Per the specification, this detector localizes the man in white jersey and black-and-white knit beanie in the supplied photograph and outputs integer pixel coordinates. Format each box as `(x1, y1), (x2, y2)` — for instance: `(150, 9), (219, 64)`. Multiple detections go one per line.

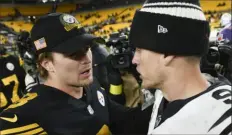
(129, 0), (232, 134)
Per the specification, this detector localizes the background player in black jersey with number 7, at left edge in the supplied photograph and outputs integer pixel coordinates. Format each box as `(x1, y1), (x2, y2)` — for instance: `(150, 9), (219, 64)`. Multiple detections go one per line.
(0, 46), (26, 112)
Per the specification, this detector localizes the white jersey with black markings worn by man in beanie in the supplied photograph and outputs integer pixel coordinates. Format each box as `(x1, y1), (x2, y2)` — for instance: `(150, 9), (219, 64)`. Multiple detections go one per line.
(148, 84), (232, 135)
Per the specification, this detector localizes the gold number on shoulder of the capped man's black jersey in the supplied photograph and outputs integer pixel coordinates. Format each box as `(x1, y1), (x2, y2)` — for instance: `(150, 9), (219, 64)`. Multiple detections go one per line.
(7, 93), (38, 109)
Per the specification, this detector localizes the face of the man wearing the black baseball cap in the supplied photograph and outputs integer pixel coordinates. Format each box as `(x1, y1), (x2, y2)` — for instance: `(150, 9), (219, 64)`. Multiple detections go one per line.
(53, 48), (93, 87)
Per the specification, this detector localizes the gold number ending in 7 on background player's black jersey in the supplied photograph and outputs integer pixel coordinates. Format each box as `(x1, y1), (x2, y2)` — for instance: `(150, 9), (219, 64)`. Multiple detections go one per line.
(0, 74), (19, 107)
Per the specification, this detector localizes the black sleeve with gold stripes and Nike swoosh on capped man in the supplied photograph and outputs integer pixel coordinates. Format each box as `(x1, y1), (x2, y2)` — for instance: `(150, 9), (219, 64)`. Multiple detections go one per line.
(0, 93), (46, 135)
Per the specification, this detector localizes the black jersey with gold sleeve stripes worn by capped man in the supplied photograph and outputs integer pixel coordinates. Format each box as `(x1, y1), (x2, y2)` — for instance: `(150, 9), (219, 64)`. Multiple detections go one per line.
(0, 79), (145, 135)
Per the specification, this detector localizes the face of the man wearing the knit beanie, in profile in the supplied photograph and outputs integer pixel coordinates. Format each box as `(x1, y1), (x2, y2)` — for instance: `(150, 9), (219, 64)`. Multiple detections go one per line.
(132, 48), (163, 88)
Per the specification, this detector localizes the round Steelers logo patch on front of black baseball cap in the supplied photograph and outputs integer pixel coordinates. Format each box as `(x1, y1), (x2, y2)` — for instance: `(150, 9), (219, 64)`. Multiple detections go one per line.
(60, 14), (81, 31)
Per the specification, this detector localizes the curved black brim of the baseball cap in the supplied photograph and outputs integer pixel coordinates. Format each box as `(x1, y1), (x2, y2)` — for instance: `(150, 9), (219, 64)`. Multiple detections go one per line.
(52, 34), (105, 54)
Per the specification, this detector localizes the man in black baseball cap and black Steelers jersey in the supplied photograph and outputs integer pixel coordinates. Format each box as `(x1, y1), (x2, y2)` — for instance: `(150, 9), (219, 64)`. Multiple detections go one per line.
(0, 13), (147, 135)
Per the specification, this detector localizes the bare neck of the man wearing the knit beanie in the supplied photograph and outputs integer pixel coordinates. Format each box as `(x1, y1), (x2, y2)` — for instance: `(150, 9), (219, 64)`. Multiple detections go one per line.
(161, 68), (209, 102)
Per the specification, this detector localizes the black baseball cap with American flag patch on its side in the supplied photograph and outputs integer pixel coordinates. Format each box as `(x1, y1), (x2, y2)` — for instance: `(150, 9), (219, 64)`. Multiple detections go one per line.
(31, 13), (104, 55)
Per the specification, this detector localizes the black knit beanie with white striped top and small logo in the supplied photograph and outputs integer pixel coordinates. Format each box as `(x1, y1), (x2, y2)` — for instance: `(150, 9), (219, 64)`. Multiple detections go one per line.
(129, 0), (209, 56)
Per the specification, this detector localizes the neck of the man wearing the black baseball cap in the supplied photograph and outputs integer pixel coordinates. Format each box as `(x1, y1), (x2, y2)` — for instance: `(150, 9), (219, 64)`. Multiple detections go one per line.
(44, 79), (83, 99)
